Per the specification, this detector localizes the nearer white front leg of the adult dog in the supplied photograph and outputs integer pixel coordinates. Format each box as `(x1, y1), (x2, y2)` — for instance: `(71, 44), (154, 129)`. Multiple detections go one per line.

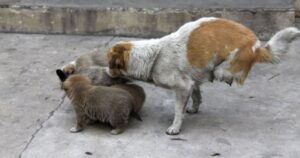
(166, 86), (192, 135)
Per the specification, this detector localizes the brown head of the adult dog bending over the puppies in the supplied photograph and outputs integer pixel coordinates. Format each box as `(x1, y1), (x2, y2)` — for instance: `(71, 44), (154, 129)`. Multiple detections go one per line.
(107, 42), (132, 77)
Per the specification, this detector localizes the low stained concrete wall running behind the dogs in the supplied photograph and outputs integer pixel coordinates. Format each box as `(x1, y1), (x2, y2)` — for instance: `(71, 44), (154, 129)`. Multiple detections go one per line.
(0, 0), (295, 39)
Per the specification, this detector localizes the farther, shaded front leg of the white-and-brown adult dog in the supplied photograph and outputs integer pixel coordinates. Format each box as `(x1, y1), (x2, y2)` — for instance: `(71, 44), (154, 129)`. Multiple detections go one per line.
(186, 85), (202, 114)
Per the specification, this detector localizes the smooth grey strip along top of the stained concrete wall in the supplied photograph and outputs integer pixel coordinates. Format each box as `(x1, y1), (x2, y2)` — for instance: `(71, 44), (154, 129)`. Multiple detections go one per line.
(15, 0), (293, 9)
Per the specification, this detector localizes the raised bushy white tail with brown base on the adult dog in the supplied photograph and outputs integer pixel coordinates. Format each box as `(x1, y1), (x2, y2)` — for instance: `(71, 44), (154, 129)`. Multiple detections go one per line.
(255, 27), (300, 63)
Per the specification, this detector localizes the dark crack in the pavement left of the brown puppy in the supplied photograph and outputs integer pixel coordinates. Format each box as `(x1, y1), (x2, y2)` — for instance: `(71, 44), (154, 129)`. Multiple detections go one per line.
(19, 94), (66, 158)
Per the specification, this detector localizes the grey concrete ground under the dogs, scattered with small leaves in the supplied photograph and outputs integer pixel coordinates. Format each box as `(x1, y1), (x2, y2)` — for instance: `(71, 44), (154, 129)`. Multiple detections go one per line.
(0, 34), (300, 158)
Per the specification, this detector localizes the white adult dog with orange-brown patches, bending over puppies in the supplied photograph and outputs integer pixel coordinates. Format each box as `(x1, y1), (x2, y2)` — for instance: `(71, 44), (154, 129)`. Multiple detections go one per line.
(107, 17), (300, 135)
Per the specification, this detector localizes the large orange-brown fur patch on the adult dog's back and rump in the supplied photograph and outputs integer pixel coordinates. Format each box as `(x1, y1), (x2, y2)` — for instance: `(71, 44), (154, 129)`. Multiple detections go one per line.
(187, 19), (257, 83)
